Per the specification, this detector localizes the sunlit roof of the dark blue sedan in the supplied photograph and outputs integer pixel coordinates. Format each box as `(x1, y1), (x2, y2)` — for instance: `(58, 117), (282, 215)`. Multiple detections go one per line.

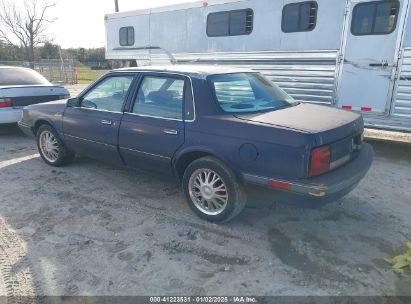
(111, 64), (255, 79)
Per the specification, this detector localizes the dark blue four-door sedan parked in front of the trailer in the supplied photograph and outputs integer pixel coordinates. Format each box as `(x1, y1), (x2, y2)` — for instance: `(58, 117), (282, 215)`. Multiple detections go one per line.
(19, 65), (373, 222)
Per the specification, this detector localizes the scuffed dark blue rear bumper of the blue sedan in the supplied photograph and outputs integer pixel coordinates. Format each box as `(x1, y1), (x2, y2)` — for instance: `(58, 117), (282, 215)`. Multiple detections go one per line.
(243, 143), (374, 206)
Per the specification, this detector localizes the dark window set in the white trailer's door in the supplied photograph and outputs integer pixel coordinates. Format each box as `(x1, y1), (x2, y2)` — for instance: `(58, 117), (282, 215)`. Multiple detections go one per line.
(351, 0), (400, 36)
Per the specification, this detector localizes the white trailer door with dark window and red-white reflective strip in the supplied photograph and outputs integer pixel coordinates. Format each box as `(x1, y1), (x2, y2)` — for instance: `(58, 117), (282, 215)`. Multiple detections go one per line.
(337, 0), (408, 114)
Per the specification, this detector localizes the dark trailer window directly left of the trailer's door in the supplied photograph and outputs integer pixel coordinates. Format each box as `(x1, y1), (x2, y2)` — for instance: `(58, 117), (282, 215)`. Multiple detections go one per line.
(281, 1), (318, 33)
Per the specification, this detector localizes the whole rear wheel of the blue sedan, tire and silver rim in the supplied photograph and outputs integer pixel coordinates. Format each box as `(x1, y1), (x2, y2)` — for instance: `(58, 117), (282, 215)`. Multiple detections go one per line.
(182, 156), (247, 223)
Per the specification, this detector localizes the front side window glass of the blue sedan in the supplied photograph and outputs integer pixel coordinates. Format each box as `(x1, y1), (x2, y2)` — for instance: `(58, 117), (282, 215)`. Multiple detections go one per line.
(81, 76), (134, 112)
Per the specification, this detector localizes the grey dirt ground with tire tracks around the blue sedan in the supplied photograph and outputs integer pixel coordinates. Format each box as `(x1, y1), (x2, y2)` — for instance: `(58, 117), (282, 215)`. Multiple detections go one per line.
(0, 85), (411, 295)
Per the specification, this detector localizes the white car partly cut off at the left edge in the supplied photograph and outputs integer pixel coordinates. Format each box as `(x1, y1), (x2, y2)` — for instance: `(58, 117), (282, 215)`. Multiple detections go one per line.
(0, 66), (70, 124)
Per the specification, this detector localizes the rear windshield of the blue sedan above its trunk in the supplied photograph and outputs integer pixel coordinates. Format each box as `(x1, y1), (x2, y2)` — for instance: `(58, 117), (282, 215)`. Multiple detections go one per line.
(208, 73), (298, 113)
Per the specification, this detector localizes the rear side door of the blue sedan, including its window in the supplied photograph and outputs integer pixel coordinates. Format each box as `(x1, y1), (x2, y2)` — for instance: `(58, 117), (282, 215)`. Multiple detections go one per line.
(119, 73), (191, 173)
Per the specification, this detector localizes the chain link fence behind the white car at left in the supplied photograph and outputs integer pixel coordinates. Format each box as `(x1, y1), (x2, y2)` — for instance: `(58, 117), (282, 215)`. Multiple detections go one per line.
(0, 59), (77, 84)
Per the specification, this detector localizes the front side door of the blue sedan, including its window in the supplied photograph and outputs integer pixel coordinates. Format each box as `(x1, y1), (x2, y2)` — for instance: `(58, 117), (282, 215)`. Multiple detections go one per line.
(63, 73), (134, 163)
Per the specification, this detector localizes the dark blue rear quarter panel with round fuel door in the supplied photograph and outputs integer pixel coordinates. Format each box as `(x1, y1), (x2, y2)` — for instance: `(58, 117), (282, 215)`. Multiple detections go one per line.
(177, 116), (315, 178)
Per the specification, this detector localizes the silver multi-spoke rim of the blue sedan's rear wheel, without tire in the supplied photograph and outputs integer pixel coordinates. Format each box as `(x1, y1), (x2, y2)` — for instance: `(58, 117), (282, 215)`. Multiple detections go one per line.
(188, 169), (228, 215)
